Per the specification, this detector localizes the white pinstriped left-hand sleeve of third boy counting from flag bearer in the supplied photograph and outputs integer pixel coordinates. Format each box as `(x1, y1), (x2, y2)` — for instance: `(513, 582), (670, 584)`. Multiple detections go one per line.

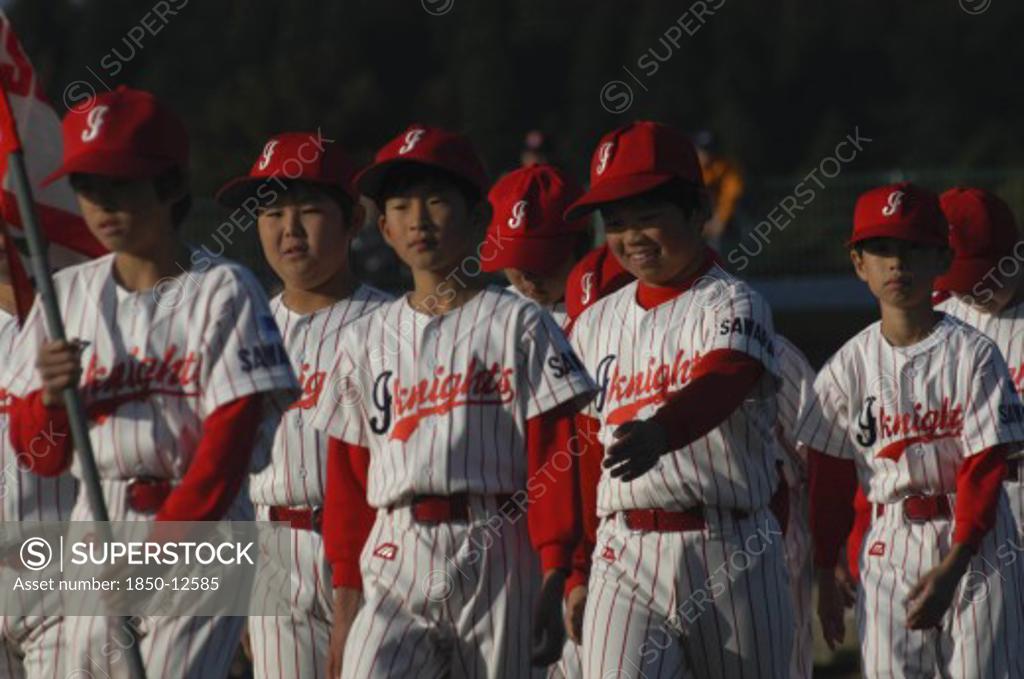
(312, 342), (370, 448)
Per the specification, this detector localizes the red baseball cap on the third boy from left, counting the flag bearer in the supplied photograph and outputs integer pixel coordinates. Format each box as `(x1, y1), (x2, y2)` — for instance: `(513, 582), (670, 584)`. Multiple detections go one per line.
(354, 123), (487, 201)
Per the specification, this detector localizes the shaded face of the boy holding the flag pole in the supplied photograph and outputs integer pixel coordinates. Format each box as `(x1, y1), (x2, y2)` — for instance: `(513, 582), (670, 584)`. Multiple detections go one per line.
(72, 174), (181, 254)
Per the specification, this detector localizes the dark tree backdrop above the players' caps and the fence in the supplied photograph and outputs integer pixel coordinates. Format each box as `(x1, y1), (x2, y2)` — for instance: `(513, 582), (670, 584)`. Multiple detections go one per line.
(8, 0), (1024, 194)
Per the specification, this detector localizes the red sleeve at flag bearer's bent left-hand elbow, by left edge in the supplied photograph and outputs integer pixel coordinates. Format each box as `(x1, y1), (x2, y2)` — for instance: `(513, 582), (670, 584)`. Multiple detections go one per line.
(8, 390), (73, 476)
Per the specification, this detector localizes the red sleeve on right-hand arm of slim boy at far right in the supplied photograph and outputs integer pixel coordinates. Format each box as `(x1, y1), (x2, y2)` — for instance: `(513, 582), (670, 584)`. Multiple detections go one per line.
(953, 445), (1007, 549)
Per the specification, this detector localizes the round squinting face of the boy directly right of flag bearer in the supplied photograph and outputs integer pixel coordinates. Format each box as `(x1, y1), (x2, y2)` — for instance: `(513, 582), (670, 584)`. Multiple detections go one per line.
(256, 192), (362, 290)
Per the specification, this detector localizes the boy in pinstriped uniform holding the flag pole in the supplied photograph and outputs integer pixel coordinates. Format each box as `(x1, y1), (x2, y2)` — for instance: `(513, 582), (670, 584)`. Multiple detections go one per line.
(3, 87), (297, 679)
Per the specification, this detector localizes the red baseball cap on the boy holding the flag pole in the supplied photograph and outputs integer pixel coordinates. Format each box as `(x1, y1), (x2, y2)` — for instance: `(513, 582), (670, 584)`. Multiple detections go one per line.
(43, 85), (188, 186)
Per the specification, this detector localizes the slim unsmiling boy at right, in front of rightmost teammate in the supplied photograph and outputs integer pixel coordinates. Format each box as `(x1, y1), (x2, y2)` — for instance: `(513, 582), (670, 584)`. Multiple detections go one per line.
(798, 182), (1024, 677)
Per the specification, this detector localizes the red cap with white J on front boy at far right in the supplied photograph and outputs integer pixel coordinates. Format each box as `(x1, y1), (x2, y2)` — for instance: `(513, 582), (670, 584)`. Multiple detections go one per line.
(847, 181), (949, 247)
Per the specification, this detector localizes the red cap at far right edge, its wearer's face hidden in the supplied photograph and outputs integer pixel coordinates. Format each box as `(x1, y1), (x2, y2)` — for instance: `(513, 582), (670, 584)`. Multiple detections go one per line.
(935, 186), (1020, 293)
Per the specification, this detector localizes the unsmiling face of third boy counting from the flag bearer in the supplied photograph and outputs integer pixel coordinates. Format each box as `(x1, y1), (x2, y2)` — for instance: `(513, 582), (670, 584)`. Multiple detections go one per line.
(379, 181), (485, 272)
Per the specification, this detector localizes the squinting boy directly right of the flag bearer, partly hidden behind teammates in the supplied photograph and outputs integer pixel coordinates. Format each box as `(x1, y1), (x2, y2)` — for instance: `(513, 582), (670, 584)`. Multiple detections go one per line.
(217, 132), (391, 677)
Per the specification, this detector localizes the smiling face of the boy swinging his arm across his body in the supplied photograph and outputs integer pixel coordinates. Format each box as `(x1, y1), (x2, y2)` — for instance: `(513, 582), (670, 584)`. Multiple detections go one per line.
(601, 200), (705, 286)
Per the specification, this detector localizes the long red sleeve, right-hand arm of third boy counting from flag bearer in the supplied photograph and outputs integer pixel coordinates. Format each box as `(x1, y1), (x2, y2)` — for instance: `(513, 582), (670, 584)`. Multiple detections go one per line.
(526, 401), (582, 572)
